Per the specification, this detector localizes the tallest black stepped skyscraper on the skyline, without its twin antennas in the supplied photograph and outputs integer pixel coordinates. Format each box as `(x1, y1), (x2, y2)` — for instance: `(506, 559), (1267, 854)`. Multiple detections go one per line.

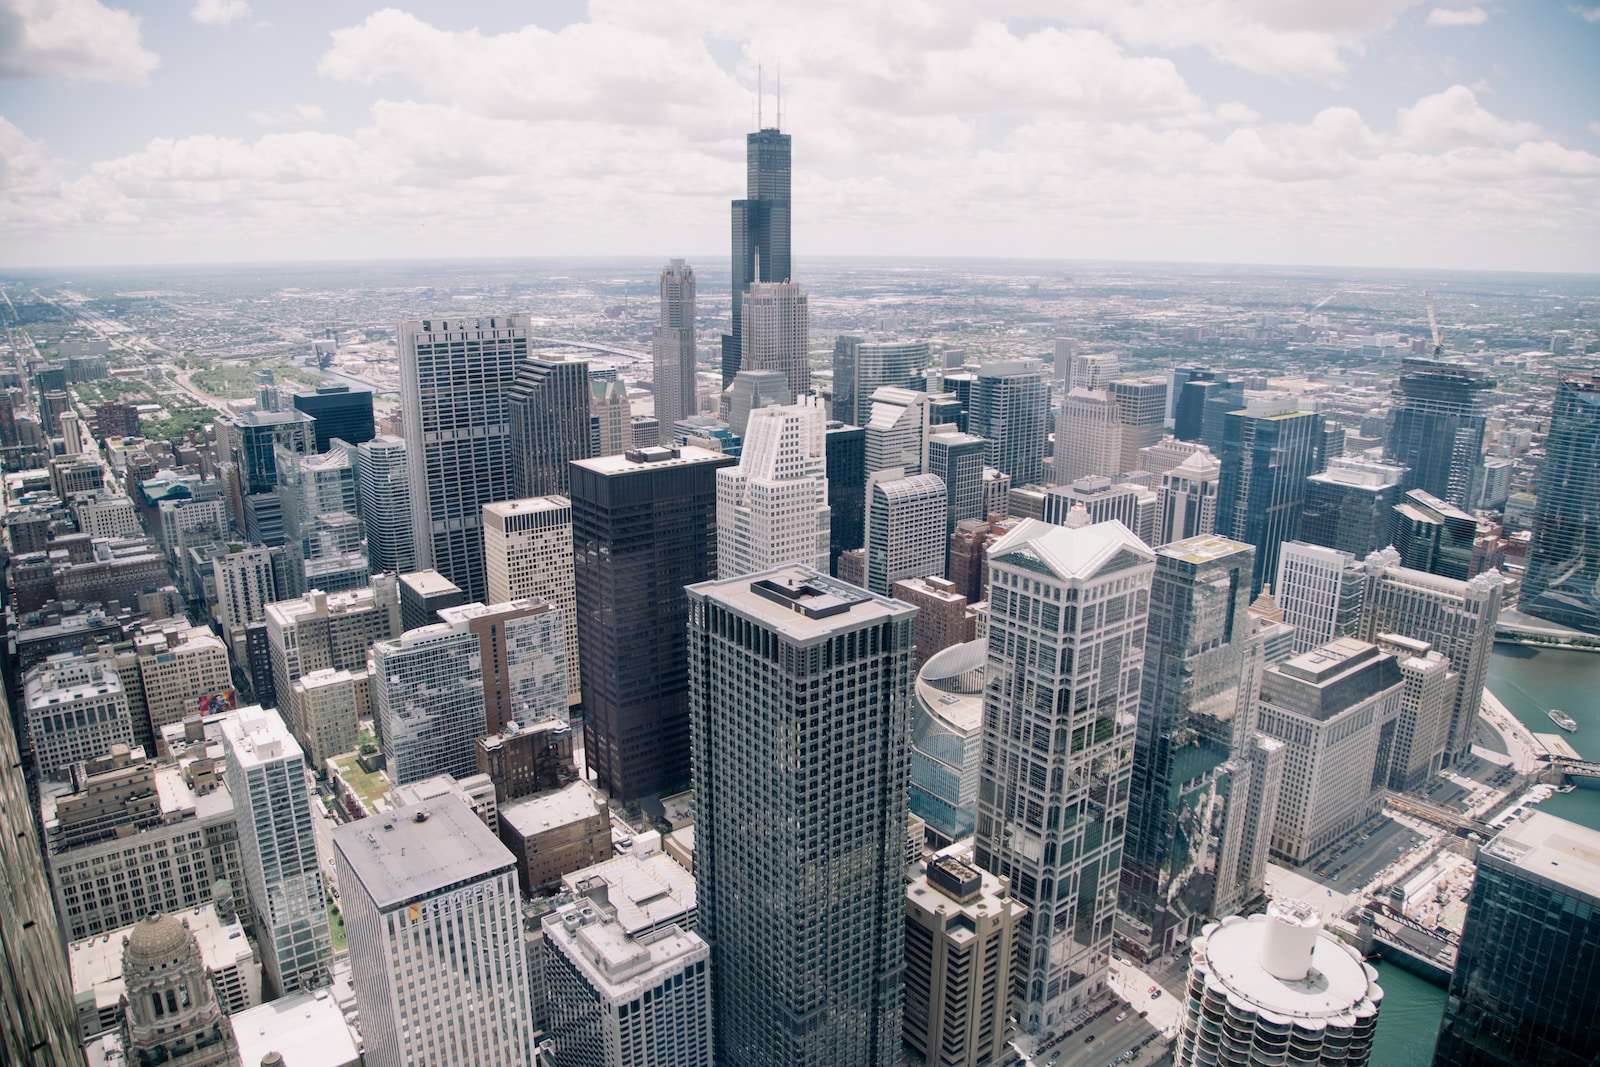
(722, 130), (789, 389)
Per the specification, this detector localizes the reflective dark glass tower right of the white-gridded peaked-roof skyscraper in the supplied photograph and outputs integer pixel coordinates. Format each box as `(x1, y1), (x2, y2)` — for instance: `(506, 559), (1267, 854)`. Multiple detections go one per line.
(1118, 536), (1259, 958)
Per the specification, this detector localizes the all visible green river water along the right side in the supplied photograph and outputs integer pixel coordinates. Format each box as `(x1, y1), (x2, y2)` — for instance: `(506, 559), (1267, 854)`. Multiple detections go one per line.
(1371, 643), (1600, 1067)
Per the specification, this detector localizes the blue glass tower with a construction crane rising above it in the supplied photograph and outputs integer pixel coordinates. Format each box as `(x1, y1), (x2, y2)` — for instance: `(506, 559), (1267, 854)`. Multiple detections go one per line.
(1384, 358), (1496, 507)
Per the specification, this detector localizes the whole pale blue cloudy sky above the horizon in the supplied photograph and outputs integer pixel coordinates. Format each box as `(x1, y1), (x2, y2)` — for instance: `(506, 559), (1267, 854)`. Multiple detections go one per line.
(0, 0), (1600, 270)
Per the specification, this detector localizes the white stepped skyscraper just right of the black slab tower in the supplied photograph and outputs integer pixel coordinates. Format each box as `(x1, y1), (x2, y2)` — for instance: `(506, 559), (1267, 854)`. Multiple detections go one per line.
(717, 404), (832, 577)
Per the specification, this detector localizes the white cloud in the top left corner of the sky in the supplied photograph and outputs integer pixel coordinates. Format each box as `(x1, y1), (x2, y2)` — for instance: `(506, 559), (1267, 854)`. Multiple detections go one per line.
(0, 0), (160, 85)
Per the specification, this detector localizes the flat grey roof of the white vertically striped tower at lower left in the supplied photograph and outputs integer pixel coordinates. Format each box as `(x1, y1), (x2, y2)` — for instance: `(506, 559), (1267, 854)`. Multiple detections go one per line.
(333, 797), (517, 910)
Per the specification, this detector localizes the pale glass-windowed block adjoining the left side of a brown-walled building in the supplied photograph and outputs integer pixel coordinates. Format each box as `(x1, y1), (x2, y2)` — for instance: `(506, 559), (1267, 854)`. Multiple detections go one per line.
(371, 622), (486, 785)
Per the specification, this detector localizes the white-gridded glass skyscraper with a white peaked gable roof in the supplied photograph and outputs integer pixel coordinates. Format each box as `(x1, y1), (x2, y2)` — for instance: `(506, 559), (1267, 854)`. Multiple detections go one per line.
(973, 520), (1155, 1032)
